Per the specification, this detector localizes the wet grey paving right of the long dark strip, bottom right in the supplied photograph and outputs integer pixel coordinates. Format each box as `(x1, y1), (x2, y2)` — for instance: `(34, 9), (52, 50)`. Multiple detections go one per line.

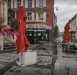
(53, 48), (77, 75)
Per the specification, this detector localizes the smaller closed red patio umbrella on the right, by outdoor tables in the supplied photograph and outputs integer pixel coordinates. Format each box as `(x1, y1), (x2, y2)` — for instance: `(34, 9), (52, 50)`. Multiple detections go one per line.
(63, 23), (70, 43)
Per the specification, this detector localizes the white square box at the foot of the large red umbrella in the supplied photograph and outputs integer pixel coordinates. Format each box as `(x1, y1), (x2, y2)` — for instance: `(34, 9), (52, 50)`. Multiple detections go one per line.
(17, 50), (37, 66)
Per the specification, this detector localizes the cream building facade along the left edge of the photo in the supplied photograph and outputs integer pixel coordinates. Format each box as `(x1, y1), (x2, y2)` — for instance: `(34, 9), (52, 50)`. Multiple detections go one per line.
(0, 0), (7, 50)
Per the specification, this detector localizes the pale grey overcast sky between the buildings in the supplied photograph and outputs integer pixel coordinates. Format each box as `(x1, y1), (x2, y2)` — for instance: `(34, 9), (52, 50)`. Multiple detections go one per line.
(54, 0), (77, 32)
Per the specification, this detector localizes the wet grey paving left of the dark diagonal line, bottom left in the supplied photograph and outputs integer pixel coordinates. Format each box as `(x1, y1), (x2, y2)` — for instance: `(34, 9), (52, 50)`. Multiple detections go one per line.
(0, 53), (18, 75)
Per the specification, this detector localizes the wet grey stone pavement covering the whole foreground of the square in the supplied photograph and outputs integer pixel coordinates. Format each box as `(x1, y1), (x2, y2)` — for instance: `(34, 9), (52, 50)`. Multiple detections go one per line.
(0, 42), (77, 75)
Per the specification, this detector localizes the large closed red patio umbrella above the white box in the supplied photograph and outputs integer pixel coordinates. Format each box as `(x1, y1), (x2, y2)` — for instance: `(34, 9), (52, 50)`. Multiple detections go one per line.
(16, 6), (30, 54)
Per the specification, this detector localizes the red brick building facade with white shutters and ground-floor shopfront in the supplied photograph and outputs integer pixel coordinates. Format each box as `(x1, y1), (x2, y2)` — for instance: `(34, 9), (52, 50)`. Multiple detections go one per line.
(8, 0), (54, 43)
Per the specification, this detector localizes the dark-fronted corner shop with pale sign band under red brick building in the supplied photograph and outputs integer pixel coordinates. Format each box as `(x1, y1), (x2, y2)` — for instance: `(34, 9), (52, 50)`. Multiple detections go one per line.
(26, 25), (50, 44)
